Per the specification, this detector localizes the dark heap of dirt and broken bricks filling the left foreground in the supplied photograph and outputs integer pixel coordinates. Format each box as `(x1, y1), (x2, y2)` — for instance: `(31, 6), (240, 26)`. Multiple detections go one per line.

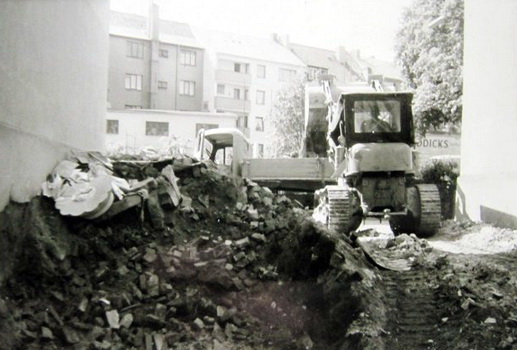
(0, 160), (382, 350)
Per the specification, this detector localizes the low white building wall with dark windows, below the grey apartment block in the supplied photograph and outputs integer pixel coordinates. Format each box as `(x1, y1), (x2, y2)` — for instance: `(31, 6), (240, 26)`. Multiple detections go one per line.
(106, 110), (237, 155)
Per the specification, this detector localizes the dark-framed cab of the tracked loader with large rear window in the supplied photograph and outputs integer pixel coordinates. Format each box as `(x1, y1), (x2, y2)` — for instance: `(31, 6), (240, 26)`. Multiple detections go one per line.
(329, 92), (415, 148)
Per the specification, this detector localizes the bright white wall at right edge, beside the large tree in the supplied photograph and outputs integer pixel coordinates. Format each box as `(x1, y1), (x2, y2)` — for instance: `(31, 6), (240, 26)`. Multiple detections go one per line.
(457, 0), (517, 228)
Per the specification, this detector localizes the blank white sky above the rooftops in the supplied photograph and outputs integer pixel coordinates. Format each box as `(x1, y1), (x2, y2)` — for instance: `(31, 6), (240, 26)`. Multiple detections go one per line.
(111, 0), (413, 60)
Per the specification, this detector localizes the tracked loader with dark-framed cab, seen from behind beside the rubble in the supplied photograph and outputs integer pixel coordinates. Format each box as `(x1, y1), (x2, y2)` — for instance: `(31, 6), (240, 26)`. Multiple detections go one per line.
(308, 80), (441, 237)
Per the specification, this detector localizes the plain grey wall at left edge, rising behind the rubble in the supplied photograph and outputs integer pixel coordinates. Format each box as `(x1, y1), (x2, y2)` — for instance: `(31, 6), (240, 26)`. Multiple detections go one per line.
(0, 0), (109, 209)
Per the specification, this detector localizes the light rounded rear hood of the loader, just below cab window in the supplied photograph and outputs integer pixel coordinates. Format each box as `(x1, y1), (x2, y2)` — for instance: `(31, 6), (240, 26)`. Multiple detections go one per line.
(345, 143), (413, 175)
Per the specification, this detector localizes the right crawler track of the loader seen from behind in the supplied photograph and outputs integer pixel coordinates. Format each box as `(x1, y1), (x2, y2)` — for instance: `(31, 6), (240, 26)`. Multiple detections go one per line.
(390, 184), (441, 237)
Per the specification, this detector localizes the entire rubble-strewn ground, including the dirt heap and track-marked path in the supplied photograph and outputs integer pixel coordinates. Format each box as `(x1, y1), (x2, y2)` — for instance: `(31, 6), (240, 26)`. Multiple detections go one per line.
(0, 159), (517, 350)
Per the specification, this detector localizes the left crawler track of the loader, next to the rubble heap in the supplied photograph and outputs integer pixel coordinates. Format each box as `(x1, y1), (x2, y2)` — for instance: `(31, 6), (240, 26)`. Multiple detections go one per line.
(313, 186), (363, 234)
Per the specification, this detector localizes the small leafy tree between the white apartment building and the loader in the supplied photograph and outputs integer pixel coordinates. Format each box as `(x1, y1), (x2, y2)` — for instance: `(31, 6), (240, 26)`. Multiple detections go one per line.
(268, 80), (305, 157)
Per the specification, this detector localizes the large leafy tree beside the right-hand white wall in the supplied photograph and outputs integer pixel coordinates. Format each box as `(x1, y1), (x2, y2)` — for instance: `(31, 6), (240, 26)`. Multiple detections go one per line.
(396, 0), (463, 135)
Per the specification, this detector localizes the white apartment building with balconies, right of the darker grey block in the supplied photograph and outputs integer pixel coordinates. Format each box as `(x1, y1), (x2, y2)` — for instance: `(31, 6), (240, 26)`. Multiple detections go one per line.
(193, 28), (306, 157)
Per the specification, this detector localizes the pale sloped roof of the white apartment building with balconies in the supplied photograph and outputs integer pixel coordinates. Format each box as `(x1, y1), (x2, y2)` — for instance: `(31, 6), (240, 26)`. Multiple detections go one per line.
(192, 27), (305, 66)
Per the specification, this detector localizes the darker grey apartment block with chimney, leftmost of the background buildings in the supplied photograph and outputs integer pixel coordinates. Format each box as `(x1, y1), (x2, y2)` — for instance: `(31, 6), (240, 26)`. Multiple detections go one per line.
(108, 6), (204, 111)
